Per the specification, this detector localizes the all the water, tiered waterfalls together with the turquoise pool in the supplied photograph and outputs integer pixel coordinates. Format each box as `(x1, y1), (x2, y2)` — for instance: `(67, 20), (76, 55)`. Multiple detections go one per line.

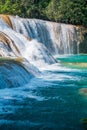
(0, 15), (87, 130)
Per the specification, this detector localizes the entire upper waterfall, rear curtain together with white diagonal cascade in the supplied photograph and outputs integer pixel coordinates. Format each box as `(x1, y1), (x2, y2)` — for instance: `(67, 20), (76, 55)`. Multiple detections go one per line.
(0, 15), (85, 68)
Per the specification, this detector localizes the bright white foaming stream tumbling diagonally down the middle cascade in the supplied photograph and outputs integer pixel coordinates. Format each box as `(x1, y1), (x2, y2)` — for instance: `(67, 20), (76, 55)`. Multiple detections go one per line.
(2, 29), (55, 67)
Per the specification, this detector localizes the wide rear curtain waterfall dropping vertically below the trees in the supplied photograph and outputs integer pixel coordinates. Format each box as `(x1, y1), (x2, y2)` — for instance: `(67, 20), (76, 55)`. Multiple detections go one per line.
(10, 16), (78, 55)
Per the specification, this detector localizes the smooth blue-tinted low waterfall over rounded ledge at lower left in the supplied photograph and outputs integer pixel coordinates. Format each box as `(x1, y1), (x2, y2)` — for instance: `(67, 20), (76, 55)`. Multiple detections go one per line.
(0, 60), (34, 89)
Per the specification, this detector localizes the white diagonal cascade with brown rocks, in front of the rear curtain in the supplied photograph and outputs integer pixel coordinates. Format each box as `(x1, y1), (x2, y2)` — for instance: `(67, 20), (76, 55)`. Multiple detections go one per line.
(0, 16), (55, 68)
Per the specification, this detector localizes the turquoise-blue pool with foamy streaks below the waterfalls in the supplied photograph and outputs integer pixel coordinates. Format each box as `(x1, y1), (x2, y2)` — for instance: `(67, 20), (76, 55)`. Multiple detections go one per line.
(0, 55), (87, 130)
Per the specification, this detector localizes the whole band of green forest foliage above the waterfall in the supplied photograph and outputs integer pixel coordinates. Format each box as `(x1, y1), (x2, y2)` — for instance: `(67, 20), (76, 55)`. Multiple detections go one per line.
(0, 0), (87, 26)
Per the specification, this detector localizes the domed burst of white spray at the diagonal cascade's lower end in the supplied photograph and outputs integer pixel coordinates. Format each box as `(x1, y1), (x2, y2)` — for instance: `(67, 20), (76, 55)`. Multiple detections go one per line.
(23, 40), (55, 67)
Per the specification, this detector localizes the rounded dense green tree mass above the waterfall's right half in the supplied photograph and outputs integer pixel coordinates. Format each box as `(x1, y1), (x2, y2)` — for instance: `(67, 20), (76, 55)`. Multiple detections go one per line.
(46, 0), (87, 26)
